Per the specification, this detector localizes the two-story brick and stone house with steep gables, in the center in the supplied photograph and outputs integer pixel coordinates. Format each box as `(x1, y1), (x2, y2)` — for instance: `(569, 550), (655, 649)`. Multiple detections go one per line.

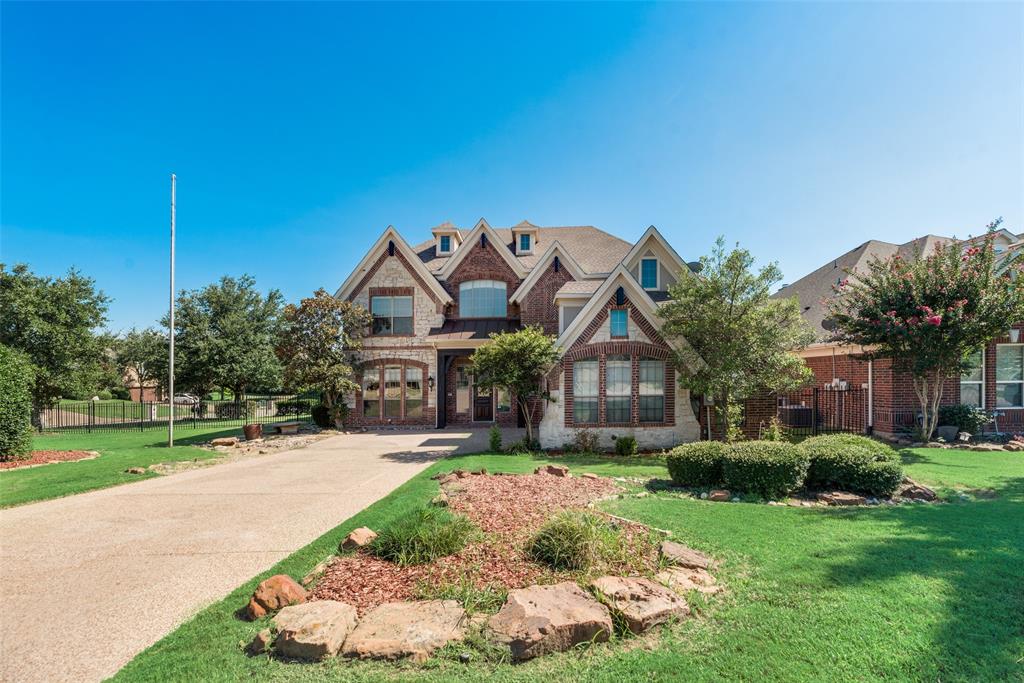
(336, 219), (699, 447)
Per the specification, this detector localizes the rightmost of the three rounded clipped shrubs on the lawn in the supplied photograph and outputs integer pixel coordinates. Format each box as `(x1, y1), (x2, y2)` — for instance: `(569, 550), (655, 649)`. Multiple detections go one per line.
(798, 434), (903, 496)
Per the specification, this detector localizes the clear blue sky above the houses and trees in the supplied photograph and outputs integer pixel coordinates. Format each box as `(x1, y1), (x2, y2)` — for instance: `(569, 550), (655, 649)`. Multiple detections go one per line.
(0, 2), (1024, 330)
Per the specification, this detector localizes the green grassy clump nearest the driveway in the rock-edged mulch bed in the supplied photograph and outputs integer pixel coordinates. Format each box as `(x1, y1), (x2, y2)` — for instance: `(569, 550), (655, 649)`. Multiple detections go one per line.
(370, 506), (476, 566)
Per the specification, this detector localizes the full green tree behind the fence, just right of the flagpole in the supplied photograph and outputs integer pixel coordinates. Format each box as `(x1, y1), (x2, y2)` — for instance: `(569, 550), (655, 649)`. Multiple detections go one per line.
(163, 275), (282, 398)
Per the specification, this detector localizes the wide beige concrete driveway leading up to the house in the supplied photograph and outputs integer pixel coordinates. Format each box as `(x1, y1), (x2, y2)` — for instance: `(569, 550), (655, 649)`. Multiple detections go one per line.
(0, 430), (505, 682)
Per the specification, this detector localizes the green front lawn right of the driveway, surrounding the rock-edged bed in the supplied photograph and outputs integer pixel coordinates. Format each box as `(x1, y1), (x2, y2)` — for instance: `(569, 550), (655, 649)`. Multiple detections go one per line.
(115, 450), (1024, 682)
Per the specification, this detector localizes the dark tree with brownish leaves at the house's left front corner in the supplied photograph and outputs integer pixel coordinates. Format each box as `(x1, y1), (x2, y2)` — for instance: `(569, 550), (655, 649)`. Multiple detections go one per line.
(278, 290), (372, 424)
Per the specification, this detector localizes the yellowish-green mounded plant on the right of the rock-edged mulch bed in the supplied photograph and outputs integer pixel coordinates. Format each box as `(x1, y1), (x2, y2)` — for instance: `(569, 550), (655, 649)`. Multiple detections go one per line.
(526, 510), (624, 569)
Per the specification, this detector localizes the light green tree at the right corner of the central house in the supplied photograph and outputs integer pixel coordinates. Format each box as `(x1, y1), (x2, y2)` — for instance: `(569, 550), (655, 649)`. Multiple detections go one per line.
(660, 238), (814, 434)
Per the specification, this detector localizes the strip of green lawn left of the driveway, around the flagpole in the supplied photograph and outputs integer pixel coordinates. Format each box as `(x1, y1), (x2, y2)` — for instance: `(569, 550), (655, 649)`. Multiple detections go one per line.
(0, 426), (242, 507)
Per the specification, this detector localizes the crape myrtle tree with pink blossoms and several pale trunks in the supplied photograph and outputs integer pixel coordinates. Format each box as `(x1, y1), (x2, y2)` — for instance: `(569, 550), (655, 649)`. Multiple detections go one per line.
(827, 219), (1024, 439)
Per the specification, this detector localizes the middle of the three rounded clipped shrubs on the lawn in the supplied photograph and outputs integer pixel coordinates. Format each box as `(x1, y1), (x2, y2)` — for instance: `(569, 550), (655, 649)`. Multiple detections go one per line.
(722, 441), (809, 498)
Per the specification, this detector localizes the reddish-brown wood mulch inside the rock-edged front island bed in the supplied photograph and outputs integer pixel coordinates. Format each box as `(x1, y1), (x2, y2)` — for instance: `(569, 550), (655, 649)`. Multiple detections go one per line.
(313, 474), (656, 614)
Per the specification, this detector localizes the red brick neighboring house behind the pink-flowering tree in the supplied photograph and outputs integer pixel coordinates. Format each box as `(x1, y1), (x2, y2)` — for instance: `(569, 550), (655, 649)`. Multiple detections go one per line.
(775, 229), (1024, 435)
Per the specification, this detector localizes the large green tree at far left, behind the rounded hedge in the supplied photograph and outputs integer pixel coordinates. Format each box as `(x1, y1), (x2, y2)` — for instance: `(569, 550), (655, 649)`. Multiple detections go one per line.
(0, 263), (110, 408)
